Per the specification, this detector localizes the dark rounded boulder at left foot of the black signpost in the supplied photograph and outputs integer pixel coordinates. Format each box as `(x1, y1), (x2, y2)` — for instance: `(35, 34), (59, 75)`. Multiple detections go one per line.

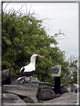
(37, 89), (55, 100)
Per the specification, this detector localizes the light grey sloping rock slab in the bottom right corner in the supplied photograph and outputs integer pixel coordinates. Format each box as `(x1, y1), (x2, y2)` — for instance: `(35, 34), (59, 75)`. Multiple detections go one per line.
(43, 92), (77, 104)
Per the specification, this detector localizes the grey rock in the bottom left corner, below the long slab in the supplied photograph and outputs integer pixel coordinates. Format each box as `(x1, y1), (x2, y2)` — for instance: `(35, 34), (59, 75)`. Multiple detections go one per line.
(2, 93), (26, 104)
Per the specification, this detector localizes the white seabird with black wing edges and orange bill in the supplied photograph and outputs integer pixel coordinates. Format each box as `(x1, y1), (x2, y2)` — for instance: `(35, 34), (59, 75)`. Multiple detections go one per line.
(17, 54), (45, 83)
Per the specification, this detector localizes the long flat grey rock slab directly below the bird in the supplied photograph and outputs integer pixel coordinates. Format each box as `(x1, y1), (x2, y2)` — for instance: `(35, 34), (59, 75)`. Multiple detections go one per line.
(3, 83), (39, 102)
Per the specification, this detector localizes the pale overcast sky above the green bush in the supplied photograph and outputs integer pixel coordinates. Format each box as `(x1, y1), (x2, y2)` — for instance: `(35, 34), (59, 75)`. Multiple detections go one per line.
(3, 3), (79, 59)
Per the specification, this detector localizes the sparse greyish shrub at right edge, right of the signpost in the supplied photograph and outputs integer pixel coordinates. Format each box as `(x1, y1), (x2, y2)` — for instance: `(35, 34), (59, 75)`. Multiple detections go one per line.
(64, 55), (78, 84)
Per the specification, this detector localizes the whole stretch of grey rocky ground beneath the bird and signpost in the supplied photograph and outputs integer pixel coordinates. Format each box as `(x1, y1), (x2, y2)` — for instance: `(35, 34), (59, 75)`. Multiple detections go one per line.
(0, 70), (79, 106)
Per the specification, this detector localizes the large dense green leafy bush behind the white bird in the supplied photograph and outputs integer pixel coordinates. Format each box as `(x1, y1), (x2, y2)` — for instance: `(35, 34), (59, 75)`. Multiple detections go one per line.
(2, 11), (69, 83)
